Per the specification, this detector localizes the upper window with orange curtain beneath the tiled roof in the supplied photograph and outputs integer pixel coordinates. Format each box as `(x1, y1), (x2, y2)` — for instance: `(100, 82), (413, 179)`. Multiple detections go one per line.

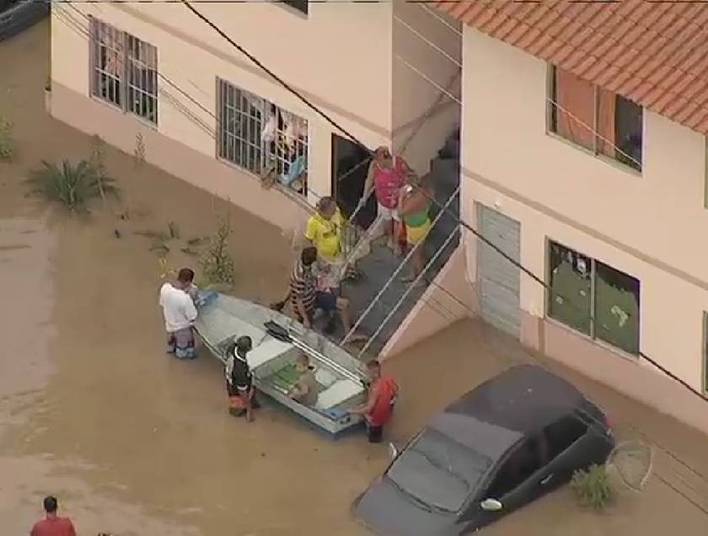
(548, 66), (643, 171)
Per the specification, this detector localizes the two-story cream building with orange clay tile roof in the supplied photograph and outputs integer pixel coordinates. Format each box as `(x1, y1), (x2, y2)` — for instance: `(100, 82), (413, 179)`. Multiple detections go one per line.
(404, 0), (708, 430)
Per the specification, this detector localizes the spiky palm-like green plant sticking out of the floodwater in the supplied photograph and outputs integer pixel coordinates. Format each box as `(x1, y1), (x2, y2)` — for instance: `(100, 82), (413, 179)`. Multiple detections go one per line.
(28, 160), (118, 212)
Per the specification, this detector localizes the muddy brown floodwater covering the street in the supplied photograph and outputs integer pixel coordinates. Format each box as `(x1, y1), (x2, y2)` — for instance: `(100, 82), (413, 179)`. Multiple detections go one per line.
(0, 18), (708, 536)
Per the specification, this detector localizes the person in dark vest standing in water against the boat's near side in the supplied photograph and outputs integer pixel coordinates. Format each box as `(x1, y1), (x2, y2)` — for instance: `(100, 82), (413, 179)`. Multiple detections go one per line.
(224, 336), (259, 422)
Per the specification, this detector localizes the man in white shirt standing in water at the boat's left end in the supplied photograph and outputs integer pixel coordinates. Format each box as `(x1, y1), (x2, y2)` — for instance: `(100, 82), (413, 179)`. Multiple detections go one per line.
(160, 268), (197, 359)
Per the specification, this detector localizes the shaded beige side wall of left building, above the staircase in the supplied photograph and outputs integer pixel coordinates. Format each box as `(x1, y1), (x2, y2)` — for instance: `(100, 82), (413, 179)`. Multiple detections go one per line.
(391, 0), (462, 174)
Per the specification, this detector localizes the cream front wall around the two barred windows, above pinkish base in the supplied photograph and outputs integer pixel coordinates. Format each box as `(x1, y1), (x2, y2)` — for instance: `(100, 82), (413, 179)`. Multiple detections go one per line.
(52, 3), (391, 211)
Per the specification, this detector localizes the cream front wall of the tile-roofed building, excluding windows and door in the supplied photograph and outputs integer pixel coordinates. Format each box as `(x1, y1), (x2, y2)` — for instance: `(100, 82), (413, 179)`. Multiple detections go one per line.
(462, 28), (708, 398)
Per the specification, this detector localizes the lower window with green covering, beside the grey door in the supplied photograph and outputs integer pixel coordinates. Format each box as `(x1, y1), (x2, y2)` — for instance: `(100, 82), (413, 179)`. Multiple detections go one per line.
(548, 242), (640, 355)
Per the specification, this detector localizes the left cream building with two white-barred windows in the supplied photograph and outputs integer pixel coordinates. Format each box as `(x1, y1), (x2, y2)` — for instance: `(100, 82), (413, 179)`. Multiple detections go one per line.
(51, 0), (461, 229)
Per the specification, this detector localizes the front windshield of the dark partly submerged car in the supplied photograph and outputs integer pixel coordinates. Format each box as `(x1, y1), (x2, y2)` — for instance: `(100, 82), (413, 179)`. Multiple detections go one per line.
(387, 429), (491, 512)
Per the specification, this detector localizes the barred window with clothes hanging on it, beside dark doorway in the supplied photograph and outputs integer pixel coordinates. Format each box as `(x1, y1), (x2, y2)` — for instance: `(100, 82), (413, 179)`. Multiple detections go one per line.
(217, 79), (308, 194)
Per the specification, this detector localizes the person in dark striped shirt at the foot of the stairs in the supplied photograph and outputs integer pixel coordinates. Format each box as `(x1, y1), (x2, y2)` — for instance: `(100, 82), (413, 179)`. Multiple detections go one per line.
(290, 246), (351, 333)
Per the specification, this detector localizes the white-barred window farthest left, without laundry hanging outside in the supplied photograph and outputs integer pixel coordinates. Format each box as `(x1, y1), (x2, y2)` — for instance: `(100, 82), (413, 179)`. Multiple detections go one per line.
(90, 17), (158, 124)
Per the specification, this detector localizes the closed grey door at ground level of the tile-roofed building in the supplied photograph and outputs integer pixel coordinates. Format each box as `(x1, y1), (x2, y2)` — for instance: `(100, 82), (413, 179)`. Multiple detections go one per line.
(477, 204), (521, 337)
